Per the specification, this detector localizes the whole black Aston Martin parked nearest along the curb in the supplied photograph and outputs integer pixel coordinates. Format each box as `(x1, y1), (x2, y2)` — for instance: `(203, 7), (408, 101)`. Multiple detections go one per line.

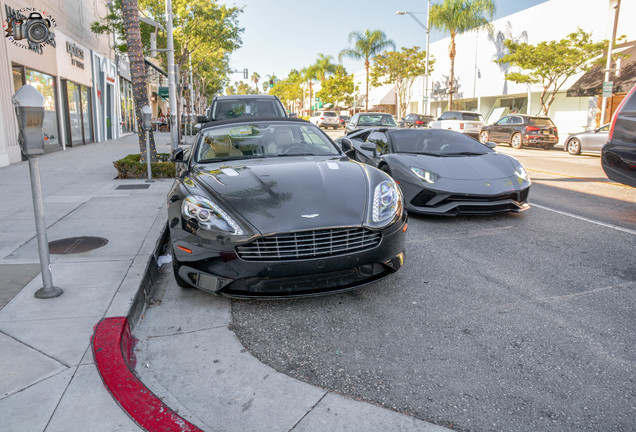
(168, 118), (407, 297)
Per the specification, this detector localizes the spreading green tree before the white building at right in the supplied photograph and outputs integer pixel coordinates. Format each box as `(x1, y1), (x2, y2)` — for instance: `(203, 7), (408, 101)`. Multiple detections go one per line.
(496, 28), (608, 115)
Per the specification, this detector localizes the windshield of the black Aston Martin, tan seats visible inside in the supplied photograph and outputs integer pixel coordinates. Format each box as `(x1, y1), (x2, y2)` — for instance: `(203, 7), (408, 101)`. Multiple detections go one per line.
(195, 122), (340, 162)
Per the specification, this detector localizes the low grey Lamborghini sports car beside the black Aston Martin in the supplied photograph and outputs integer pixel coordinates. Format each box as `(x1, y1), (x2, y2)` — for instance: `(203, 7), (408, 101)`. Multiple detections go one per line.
(336, 128), (530, 216)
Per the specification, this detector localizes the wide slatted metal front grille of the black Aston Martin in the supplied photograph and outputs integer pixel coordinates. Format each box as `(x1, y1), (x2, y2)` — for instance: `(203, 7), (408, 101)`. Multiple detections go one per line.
(236, 228), (382, 261)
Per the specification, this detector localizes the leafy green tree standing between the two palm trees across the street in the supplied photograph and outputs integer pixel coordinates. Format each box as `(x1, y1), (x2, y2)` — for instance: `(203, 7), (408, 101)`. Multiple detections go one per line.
(371, 46), (434, 117)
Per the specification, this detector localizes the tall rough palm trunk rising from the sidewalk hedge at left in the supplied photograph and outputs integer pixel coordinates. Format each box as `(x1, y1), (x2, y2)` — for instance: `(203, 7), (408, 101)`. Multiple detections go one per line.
(121, 0), (157, 162)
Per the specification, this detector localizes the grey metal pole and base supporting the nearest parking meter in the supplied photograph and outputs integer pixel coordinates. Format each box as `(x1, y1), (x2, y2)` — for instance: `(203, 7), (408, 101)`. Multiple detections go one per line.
(29, 156), (64, 298)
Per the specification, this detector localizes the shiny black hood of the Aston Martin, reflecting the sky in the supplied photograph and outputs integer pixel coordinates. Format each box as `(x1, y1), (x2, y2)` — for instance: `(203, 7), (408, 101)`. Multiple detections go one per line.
(192, 156), (369, 235)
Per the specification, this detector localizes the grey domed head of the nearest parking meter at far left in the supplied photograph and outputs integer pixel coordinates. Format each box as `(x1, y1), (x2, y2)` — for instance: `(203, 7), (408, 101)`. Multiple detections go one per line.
(11, 84), (44, 157)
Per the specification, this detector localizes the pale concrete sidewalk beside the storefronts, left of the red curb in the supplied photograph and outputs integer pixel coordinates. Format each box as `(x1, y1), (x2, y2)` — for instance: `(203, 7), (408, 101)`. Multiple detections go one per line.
(0, 134), (172, 431)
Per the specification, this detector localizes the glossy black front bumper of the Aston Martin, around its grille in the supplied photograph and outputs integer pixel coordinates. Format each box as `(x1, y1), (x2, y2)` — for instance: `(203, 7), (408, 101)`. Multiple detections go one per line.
(171, 214), (407, 298)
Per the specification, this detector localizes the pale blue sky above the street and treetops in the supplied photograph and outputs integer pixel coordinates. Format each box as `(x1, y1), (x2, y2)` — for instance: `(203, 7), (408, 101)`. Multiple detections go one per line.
(225, 0), (547, 86)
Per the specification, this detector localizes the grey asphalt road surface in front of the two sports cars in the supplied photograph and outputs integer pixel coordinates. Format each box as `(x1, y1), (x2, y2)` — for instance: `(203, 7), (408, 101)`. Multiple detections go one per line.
(148, 132), (636, 431)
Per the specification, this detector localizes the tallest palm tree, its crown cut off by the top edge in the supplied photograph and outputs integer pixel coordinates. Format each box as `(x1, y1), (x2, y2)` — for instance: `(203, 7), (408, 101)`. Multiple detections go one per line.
(429, 0), (495, 111)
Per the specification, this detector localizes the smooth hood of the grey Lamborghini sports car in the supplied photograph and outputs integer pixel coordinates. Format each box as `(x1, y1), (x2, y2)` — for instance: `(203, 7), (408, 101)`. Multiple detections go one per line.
(400, 153), (515, 180)
